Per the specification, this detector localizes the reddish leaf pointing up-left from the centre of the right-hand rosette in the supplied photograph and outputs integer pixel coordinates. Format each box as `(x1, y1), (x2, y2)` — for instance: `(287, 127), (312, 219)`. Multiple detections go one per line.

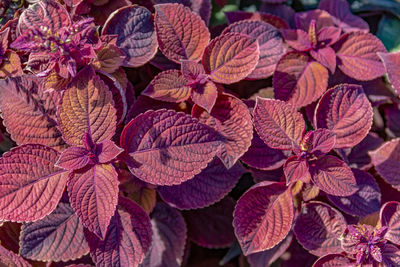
(253, 97), (305, 150)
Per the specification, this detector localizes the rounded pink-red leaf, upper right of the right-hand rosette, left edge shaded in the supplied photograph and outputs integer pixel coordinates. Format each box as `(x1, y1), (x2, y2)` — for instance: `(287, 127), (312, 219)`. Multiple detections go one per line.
(314, 84), (372, 148)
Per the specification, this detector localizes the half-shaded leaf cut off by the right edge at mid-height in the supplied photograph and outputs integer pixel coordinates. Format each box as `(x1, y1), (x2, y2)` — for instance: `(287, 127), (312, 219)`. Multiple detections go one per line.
(370, 138), (400, 191)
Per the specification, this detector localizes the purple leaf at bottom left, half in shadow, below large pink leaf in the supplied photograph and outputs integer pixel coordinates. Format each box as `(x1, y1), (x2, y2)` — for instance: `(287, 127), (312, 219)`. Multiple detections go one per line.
(20, 202), (89, 261)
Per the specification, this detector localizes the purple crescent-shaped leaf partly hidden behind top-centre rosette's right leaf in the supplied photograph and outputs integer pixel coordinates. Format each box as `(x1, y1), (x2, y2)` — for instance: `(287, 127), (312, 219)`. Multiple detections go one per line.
(222, 20), (286, 79)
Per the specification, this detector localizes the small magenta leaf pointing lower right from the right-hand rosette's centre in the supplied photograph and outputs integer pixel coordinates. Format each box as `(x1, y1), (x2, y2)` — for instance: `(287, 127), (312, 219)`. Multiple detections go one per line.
(310, 155), (358, 196)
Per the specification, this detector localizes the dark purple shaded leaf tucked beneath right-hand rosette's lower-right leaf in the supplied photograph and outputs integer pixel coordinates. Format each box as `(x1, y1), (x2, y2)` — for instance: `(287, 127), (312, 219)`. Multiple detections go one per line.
(328, 169), (381, 217)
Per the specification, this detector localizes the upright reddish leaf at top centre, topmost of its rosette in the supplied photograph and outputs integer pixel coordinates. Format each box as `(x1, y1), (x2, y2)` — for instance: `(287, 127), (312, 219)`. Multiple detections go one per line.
(154, 4), (210, 63)
